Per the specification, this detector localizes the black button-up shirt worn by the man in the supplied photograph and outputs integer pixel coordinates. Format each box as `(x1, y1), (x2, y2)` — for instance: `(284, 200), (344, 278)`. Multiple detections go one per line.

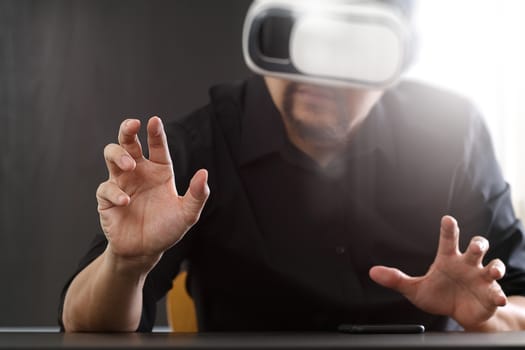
(59, 77), (525, 331)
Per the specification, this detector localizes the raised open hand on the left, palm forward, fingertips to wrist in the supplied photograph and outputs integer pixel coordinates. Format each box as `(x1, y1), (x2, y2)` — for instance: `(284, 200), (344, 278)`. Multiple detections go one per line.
(97, 117), (210, 272)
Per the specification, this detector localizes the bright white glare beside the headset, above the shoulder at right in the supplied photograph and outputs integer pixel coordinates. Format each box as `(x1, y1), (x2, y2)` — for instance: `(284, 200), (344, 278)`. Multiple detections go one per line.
(408, 0), (525, 219)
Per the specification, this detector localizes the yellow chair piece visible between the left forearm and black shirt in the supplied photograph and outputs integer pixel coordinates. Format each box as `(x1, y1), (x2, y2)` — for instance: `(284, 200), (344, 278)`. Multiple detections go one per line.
(166, 271), (198, 332)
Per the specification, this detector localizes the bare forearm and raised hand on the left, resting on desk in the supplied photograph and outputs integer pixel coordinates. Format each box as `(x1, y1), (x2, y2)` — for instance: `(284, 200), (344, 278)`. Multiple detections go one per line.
(62, 117), (209, 331)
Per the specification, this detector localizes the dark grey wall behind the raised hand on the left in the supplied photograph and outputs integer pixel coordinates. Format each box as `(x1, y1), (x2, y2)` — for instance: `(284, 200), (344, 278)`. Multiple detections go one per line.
(0, 0), (250, 326)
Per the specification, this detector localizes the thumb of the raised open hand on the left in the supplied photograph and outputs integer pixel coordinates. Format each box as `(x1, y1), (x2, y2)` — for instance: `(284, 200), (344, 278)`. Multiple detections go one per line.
(182, 169), (210, 226)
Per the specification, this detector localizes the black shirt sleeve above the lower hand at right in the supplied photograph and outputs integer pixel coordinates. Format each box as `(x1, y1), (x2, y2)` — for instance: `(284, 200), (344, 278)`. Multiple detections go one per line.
(446, 108), (525, 296)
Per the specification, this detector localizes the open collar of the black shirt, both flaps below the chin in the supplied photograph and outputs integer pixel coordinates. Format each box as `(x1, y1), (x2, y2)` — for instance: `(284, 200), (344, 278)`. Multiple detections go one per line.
(240, 76), (397, 165)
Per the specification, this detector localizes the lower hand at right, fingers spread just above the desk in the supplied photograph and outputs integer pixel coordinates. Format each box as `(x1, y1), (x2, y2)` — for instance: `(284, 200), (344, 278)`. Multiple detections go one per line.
(369, 216), (507, 330)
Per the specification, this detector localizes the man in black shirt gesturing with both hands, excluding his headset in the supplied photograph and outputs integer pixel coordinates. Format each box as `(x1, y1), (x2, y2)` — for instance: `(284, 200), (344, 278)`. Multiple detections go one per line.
(60, 0), (525, 331)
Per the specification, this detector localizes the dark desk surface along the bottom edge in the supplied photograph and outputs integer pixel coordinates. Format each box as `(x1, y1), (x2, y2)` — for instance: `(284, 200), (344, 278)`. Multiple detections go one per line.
(0, 332), (525, 350)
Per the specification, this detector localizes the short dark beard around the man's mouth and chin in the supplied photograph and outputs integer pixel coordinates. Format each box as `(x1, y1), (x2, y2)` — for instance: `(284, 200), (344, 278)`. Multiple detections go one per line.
(283, 82), (350, 146)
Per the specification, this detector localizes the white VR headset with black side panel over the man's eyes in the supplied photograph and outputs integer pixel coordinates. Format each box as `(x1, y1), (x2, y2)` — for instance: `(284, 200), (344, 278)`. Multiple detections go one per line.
(243, 0), (413, 88)
